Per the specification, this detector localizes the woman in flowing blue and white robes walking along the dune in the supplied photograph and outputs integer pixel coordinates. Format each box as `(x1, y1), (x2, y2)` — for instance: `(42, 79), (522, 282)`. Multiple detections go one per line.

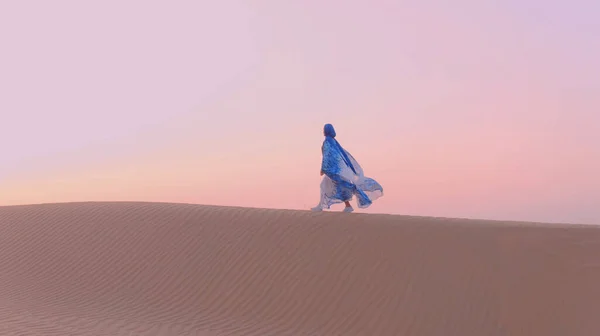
(312, 124), (383, 212)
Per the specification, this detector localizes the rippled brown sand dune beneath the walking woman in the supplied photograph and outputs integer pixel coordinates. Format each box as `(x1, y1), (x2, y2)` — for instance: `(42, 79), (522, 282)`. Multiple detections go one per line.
(0, 203), (600, 336)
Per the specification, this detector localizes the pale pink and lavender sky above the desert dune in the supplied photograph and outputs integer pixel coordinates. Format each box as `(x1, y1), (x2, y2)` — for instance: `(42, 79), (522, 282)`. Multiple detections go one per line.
(0, 0), (600, 224)
